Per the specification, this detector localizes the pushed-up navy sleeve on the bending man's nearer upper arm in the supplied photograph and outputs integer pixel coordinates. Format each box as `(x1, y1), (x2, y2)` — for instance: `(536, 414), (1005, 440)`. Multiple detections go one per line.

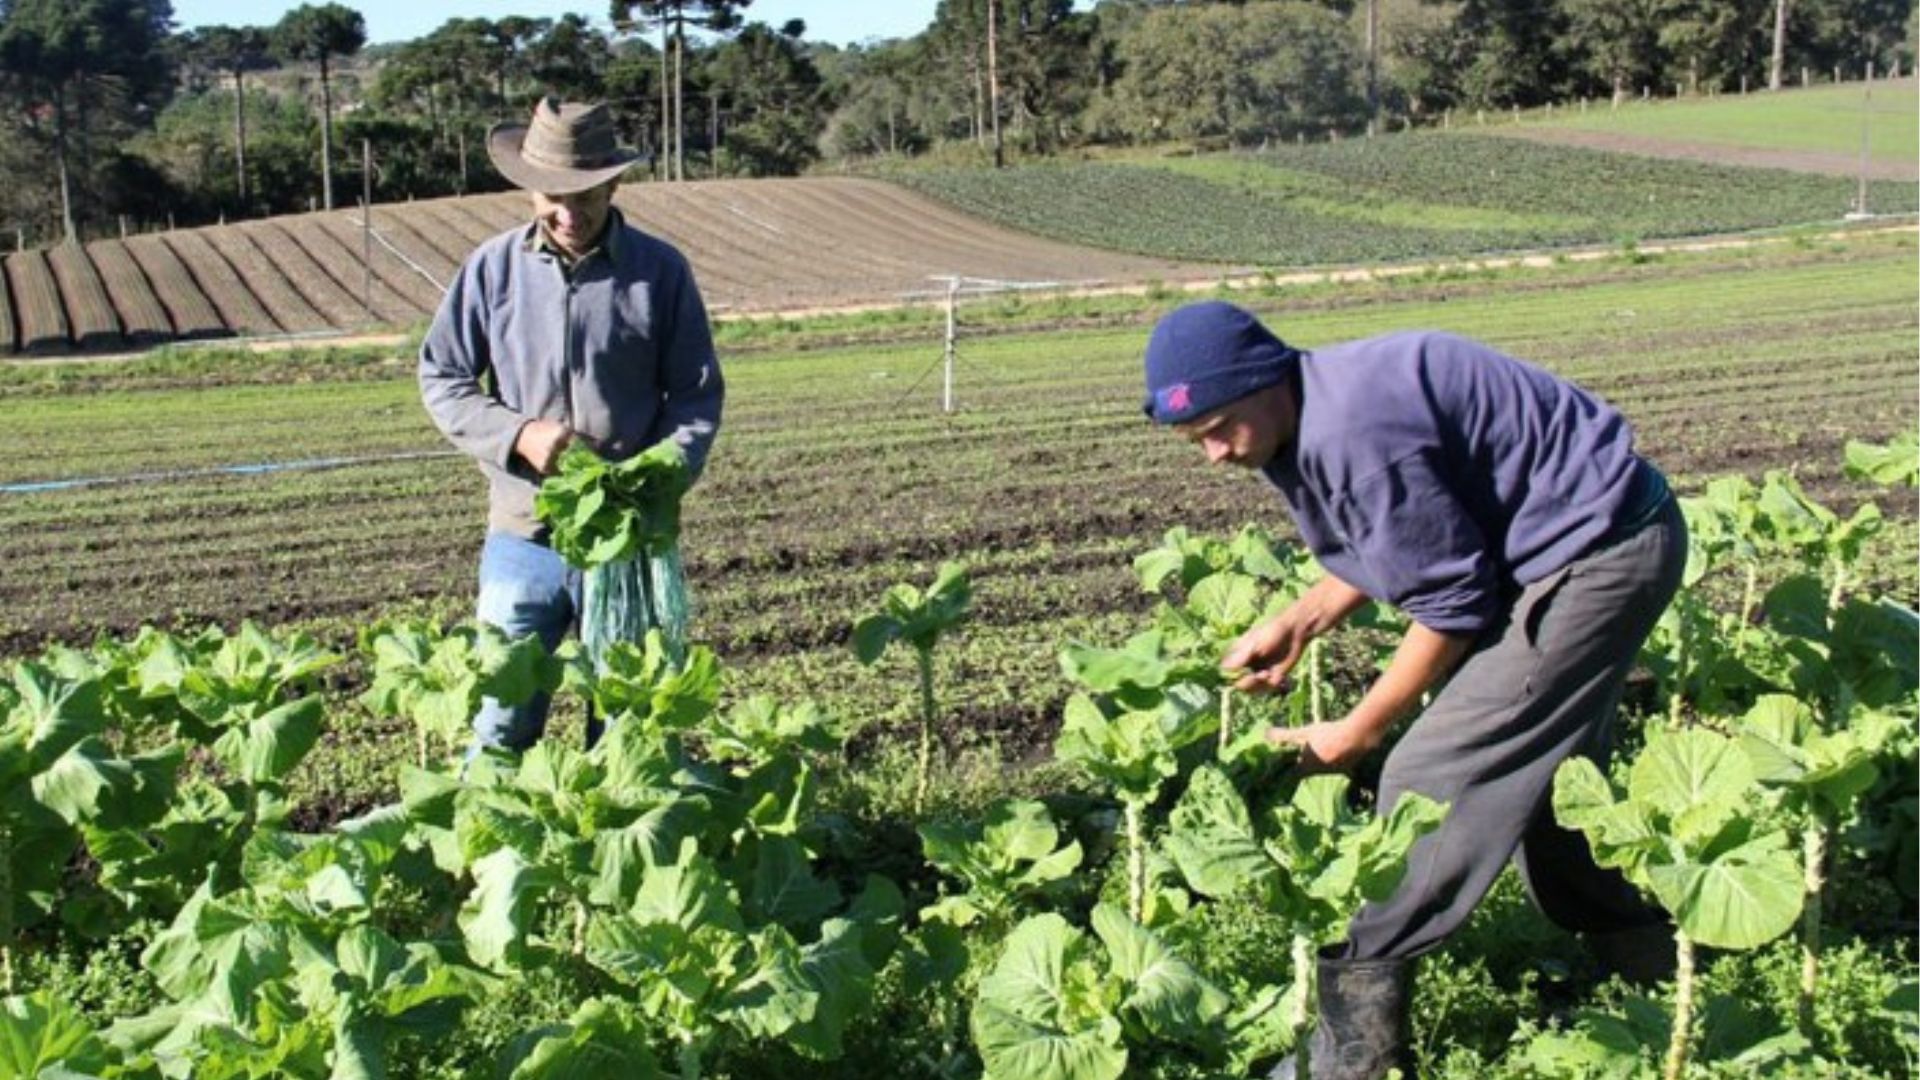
(1336, 450), (1500, 634)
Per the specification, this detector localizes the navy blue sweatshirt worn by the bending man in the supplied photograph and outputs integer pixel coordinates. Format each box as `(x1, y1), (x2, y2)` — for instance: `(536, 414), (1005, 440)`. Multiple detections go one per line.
(1265, 332), (1665, 634)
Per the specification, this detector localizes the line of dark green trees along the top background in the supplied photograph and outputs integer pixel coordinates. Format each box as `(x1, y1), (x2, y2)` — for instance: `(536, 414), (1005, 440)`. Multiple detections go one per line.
(0, 0), (1916, 240)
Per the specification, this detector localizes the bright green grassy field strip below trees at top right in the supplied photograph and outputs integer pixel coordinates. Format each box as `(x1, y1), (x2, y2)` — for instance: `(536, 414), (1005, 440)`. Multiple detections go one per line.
(1524, 79), (1920, 167)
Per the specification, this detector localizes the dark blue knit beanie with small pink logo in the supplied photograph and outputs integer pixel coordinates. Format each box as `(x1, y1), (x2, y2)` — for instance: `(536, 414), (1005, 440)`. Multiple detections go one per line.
(1144, 300), (1300, 425)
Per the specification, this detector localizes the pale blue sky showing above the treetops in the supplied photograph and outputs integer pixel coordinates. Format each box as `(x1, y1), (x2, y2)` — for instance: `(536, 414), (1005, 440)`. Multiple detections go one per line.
(173, 0), (967, 44)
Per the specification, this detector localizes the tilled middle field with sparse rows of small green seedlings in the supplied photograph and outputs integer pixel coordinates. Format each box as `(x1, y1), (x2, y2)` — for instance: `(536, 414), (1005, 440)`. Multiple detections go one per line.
(0, 236), (1916, 749)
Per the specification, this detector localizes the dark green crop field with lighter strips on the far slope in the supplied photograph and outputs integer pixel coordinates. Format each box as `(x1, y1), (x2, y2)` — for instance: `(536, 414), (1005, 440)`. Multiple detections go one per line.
(897, 133), (1920, 269)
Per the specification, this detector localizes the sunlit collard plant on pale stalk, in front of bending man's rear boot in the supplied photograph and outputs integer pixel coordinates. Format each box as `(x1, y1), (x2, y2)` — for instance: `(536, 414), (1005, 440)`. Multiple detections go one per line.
(1553, 728), (1803, 1080)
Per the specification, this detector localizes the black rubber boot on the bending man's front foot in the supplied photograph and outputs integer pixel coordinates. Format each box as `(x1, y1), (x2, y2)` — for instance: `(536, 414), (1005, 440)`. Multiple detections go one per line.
(1267, 957), (1413, 1080)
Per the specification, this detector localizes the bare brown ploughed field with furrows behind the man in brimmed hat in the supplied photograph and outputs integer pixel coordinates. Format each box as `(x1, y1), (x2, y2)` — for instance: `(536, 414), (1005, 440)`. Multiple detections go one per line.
(0, 179), (1219, 356)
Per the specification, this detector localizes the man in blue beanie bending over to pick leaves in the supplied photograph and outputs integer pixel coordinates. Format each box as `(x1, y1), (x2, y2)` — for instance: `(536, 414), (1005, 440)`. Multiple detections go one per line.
(1146, 302), (1686, 1080)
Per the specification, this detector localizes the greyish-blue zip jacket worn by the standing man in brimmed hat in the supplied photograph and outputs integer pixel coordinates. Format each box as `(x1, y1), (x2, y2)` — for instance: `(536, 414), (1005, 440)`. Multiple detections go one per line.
(420, 211), (724, 538)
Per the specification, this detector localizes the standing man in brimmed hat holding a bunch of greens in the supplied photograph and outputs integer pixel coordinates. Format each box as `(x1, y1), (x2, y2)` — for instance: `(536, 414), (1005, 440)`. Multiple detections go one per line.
(419, 98), (724, 749)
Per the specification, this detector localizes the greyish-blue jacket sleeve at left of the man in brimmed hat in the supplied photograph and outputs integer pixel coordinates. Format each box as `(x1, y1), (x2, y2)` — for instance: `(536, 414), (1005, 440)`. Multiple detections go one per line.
(419, 258), (526, 469)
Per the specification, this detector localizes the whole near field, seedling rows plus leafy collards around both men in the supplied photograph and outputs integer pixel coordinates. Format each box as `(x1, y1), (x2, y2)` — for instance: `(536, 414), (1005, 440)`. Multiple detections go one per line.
(0, 231), (1920, 1080)
